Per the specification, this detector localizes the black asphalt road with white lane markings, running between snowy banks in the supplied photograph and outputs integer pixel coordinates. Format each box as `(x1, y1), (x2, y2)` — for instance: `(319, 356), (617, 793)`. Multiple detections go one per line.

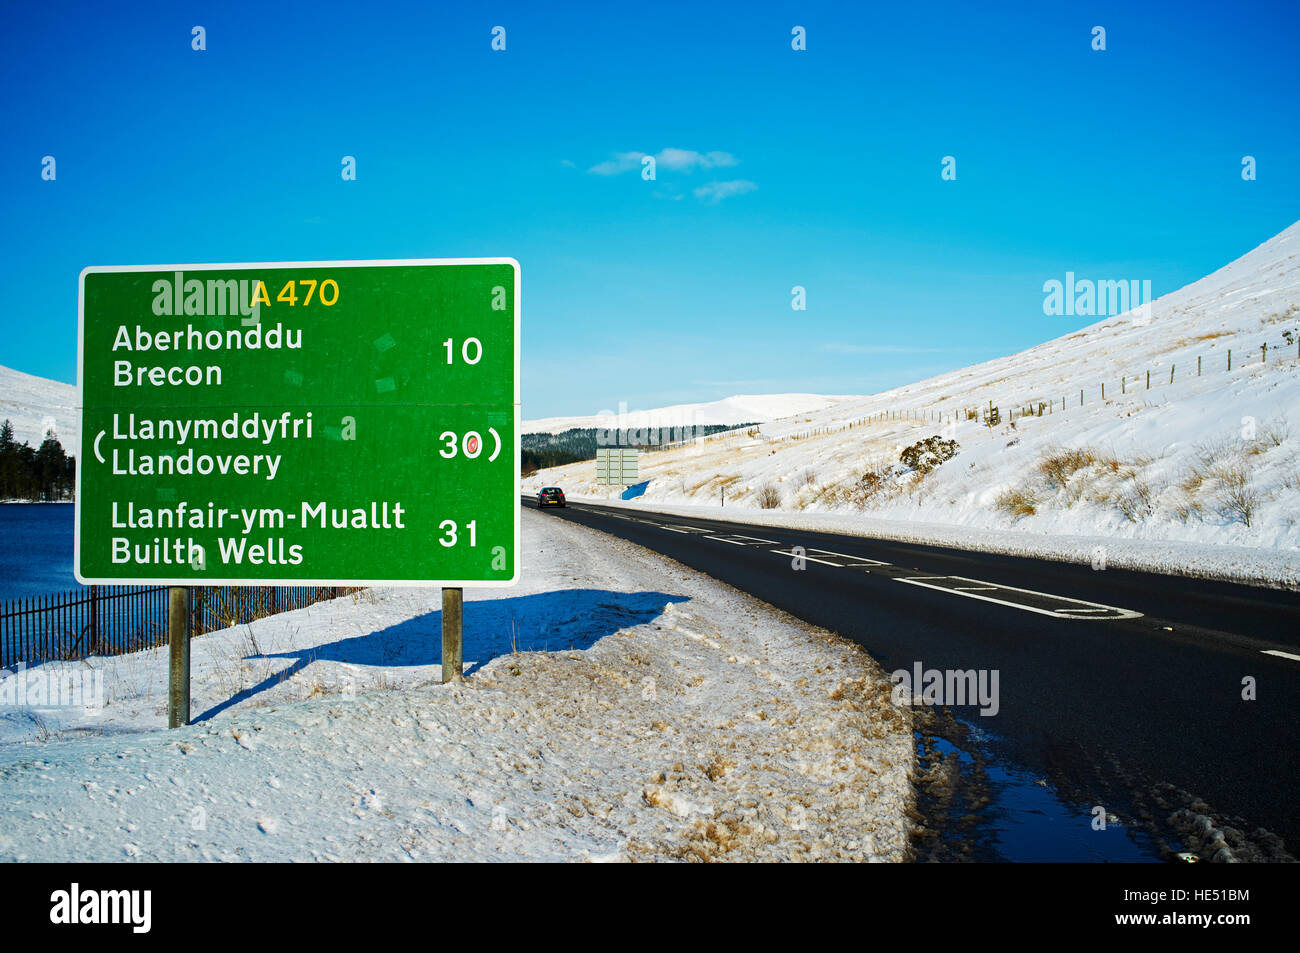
(524, 497), (1300, 855)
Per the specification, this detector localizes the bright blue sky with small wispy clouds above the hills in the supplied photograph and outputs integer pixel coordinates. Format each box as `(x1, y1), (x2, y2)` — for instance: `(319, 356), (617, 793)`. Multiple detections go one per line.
(0, 0), (1300, 417)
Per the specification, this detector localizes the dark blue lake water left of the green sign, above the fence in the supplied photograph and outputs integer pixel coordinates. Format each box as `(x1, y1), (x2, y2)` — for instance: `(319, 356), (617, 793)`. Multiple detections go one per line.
(0, 503), (81, 599)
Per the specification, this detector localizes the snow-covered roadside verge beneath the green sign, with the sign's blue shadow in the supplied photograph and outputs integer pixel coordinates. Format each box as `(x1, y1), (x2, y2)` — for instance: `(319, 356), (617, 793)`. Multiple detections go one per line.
(0, 511), (913, 861)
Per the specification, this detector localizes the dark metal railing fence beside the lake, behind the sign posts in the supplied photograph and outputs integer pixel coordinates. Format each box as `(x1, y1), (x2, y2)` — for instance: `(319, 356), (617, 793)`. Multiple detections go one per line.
(0, 585), (358, 668)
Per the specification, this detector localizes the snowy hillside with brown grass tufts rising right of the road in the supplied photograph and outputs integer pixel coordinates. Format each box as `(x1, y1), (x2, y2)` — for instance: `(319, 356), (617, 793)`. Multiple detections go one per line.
(524, 222), (1300, 550)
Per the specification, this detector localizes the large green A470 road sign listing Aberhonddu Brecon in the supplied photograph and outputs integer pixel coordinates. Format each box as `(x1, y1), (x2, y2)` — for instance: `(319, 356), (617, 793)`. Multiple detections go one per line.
(74, 259), (520, 586)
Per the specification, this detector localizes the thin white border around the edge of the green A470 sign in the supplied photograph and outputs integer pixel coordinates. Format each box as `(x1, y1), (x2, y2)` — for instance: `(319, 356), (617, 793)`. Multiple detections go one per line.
(73, 257), (523, 589)
